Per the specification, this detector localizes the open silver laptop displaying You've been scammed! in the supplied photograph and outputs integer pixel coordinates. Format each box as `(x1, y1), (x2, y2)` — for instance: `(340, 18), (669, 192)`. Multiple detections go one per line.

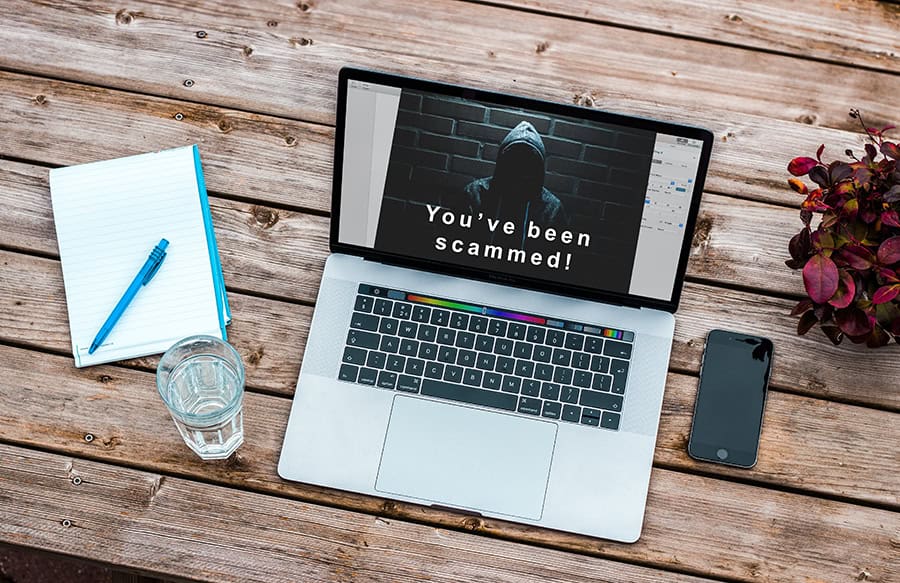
(278, 68), (713, 542)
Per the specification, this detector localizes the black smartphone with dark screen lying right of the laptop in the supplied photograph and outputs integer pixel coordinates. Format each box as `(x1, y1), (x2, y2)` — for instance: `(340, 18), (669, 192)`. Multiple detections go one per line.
(688, 330), (773, 468)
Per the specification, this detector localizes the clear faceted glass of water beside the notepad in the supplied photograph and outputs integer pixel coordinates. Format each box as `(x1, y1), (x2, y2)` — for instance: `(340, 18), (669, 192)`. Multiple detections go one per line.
(156, 336), (244, 460)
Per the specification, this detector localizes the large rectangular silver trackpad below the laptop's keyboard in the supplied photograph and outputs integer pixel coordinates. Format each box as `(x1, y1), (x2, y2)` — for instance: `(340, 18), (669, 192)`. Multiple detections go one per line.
(375, 396), (556, 520)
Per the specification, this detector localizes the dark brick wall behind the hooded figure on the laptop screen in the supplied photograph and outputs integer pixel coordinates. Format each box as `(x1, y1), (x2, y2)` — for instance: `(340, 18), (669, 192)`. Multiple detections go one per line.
(385, 90), (653, 232)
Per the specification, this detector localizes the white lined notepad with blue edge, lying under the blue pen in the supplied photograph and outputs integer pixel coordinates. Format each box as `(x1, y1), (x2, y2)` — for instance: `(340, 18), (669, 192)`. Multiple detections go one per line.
(50, 146), (231, 367)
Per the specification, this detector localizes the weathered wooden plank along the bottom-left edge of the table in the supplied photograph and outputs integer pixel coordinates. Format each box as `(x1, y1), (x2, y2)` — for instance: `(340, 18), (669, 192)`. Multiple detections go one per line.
(0, 446), (724, 583)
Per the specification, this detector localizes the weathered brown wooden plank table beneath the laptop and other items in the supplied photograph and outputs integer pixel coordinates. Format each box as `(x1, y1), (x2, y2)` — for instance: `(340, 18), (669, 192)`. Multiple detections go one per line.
(0, 0), (900, 582)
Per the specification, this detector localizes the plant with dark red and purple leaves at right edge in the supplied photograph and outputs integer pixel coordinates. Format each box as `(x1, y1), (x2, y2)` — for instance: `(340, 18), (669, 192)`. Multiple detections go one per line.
(785, 109), (900, 348)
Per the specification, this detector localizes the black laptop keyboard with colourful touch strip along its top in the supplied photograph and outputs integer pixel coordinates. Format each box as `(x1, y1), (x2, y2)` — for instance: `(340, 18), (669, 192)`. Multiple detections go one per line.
(338, 284), (634, 430)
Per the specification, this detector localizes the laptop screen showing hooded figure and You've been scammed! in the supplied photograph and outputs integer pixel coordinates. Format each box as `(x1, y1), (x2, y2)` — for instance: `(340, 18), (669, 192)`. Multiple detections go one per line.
(336, 72), (705, 302)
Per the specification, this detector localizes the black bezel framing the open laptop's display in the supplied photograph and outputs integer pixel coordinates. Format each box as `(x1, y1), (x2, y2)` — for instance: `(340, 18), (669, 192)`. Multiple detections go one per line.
(329, 67), (713, 312)
